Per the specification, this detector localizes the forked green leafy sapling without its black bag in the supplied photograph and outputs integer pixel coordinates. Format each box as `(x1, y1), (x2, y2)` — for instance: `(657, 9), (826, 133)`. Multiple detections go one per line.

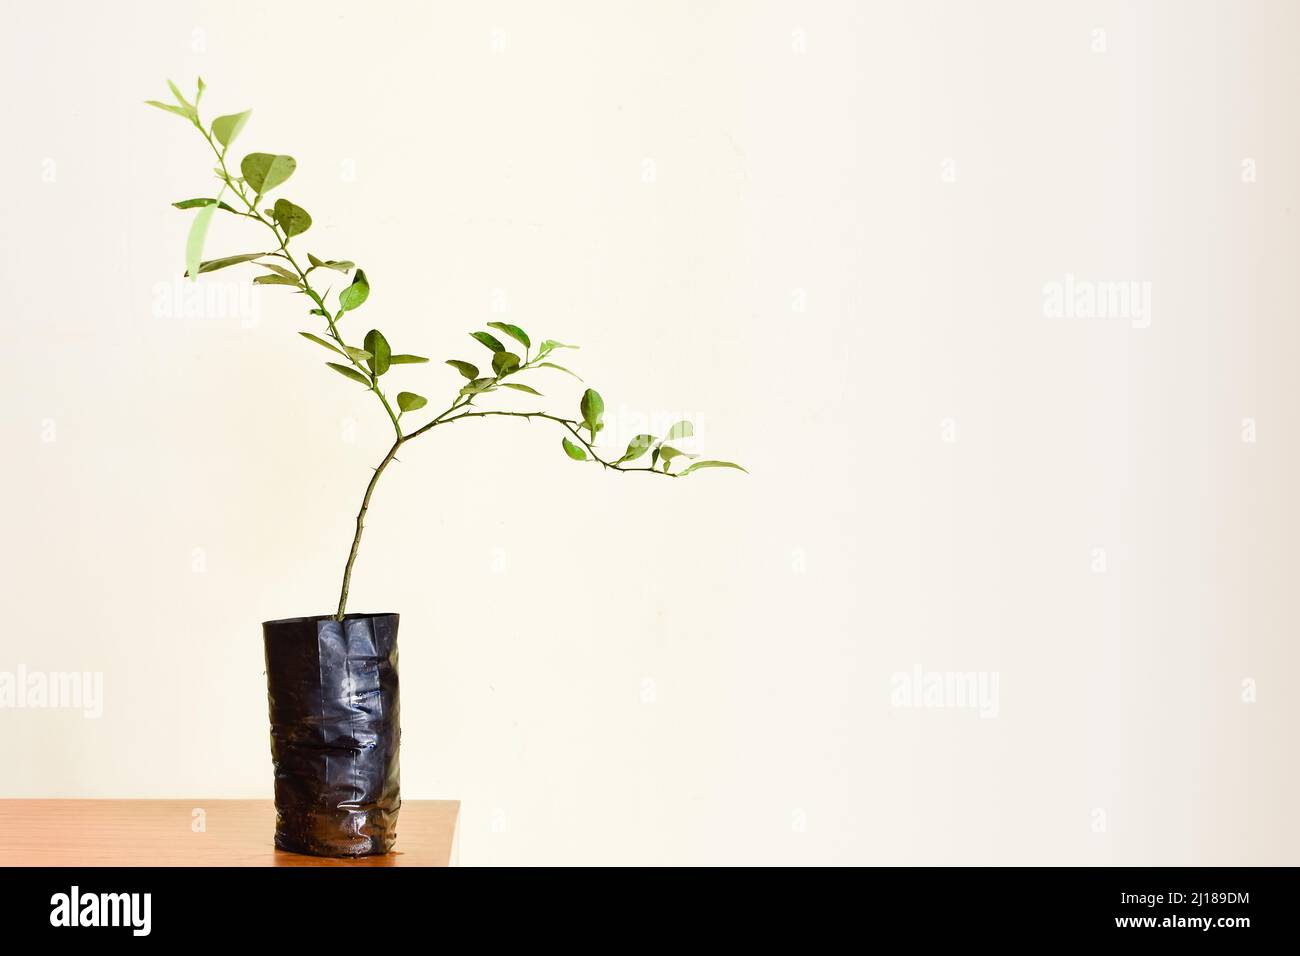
(147, 77), (745, 620)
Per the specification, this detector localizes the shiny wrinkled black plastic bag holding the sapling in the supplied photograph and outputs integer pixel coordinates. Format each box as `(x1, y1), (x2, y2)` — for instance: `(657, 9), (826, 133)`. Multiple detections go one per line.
(261, 614), (402, 856)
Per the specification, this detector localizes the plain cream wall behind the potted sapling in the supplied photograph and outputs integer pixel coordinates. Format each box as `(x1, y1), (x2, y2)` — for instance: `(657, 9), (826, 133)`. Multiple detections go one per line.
(0, 0), (1300, 864)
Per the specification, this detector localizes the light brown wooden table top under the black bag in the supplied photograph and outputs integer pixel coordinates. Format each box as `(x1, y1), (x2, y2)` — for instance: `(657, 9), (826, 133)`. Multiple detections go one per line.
(0, 800), (460, 866)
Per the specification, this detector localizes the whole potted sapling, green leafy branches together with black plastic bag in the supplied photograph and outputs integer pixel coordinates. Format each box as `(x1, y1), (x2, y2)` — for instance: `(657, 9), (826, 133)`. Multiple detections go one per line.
(148, 78), (744, 856)
